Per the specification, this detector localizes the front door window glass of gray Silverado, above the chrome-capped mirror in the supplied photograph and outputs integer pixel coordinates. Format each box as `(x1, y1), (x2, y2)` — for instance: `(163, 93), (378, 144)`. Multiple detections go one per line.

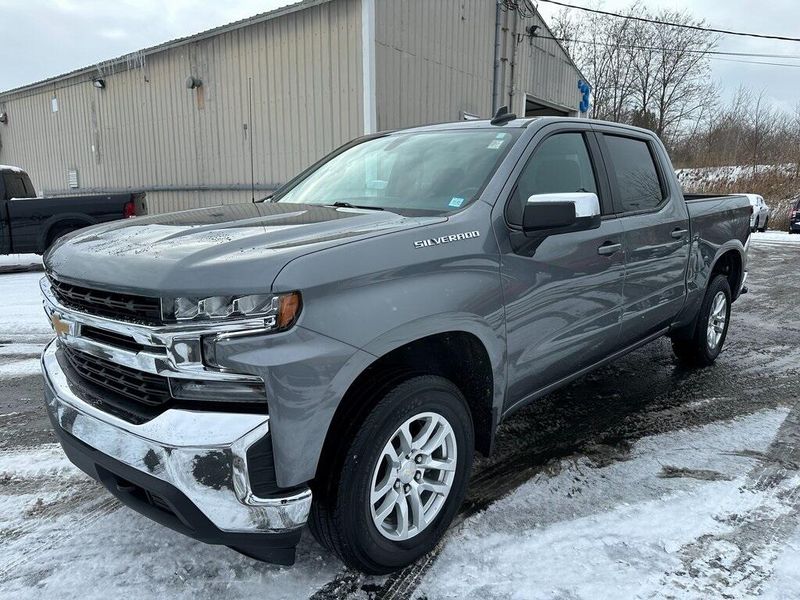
(507, 133), (597, 224)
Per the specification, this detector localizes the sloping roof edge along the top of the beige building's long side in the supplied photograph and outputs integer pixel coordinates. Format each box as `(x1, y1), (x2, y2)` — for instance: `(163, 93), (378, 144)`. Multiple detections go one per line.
(0, 0), (332, 100)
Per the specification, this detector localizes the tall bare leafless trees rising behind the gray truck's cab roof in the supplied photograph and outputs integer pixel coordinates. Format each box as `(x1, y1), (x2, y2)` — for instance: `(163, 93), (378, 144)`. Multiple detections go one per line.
(553, 1), (717, 141)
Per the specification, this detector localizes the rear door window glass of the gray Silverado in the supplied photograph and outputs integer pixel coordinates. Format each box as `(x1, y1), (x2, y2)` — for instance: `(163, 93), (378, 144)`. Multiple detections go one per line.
(603, 135), (664, 212)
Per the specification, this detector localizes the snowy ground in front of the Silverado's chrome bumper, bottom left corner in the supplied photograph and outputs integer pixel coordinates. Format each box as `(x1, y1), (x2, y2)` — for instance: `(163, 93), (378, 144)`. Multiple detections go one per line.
(0, 445), (341, 600)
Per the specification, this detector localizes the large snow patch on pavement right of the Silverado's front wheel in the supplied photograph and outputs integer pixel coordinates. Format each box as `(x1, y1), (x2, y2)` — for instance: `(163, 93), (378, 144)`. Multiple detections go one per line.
(418, 409), (800, 599)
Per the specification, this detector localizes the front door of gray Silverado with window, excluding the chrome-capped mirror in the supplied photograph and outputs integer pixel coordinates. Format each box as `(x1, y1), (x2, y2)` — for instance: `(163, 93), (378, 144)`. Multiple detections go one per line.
(495, 122), (624, 409)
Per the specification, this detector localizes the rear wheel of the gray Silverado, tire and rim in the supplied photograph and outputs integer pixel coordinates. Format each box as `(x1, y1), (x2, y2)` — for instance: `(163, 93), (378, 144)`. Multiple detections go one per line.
(672, 275), (731, 367)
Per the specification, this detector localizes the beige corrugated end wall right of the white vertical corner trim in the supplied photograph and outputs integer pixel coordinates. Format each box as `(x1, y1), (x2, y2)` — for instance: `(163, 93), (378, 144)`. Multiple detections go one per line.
(375, 0), (580, 129)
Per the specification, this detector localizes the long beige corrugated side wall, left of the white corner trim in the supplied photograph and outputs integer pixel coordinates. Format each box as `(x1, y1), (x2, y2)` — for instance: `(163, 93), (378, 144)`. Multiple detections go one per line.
(0, 0), (362, 212)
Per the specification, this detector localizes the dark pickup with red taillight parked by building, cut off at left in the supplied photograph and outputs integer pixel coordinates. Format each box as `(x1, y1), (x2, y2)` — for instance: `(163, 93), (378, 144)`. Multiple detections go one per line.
(0, 165), (147, 254)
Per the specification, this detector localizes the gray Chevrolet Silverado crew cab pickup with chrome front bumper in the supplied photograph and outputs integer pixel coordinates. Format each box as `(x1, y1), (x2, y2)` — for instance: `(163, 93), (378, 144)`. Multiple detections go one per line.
(41, 115), (751, 573)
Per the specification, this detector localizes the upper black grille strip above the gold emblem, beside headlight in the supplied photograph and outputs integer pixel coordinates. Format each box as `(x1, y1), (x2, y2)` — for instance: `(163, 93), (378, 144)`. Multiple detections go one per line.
(50, 279), (161, 323)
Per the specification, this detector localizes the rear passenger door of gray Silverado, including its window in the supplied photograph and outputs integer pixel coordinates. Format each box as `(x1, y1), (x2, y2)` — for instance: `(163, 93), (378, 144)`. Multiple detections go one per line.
(598, 127), (691, 346)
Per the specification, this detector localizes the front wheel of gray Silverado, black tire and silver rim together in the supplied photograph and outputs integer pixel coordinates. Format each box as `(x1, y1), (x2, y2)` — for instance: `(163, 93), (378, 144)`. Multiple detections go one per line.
(309, 375), (475, 574)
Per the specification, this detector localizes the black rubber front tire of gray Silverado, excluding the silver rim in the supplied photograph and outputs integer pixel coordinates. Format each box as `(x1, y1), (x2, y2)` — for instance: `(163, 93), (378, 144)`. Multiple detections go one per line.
(309, 375), (475, 574)
